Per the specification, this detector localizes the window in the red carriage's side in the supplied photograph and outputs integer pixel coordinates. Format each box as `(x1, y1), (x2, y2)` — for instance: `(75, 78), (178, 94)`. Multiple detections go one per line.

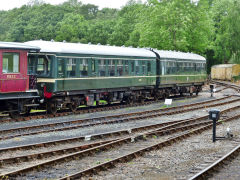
(2, 53), (19, 73)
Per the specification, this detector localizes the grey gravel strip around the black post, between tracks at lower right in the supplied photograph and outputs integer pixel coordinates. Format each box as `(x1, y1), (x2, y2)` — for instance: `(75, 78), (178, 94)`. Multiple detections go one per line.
(91, 119), (240, 180)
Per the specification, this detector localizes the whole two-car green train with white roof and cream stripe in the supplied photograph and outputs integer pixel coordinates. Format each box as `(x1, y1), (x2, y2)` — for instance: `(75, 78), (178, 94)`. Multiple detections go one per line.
(26, 40), (206, 113)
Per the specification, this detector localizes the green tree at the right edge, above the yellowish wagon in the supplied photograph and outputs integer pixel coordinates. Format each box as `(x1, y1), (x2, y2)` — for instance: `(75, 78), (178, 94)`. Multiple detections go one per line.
(212, 0), (240, 63)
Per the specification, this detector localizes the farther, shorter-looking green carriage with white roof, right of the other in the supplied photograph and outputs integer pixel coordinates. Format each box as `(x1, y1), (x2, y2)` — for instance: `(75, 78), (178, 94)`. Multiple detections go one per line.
(155, 50), (207, 93)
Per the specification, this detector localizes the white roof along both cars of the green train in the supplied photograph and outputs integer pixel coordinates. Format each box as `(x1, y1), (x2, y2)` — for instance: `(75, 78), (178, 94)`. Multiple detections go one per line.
(25, 40), (206, 61)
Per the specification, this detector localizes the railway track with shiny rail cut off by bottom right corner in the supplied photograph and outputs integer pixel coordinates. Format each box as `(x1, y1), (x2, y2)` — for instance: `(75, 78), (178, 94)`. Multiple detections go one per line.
(189, 142), (240, 180)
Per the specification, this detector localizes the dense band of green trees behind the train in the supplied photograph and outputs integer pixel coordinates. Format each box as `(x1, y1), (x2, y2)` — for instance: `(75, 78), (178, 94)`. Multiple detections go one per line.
(0, 0), (240, 71)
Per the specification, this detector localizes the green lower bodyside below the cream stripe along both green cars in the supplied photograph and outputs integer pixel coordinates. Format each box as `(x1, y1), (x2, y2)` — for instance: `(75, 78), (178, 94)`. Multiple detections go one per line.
(41, 75), (206, 92)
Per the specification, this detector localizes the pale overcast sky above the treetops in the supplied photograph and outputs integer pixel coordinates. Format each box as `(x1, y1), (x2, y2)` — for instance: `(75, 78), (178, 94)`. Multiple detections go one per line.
(0, 0), (145, 10)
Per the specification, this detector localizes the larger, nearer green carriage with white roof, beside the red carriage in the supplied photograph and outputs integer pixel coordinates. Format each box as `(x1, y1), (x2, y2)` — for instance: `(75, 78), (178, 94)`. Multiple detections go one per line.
(26, 41), (156, 113)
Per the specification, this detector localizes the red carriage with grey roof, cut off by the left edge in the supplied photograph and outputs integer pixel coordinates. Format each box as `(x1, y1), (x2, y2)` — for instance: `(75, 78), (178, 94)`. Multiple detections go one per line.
(0, 42), (39, 116)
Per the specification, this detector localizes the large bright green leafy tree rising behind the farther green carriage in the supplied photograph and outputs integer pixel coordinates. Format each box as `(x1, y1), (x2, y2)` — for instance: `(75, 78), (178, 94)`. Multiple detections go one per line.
(135, 0), (211, 53)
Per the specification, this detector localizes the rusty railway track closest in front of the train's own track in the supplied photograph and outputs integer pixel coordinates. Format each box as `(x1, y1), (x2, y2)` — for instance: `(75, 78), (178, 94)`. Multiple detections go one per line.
(0, 97), (240, 140)
